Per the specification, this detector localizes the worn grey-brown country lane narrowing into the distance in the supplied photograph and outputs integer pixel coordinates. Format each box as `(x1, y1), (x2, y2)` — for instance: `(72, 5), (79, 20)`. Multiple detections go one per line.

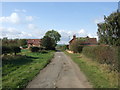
(26, 52), (92, 88)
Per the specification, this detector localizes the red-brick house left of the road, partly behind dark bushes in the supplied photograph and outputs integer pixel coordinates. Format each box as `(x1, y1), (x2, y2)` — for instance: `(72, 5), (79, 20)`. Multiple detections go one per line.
(27, 39), (42, 48)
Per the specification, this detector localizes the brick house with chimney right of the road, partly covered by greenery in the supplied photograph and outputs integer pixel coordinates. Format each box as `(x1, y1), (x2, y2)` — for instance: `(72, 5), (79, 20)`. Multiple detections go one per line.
(69, 35), (97, 48)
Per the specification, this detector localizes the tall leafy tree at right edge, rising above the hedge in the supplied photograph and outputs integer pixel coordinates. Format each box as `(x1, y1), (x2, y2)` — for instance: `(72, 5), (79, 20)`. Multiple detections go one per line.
(97, 11), (120, 46)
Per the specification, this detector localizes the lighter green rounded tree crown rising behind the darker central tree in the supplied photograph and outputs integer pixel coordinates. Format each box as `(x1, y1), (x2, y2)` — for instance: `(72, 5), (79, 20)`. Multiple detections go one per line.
(45, 30), (61, 44)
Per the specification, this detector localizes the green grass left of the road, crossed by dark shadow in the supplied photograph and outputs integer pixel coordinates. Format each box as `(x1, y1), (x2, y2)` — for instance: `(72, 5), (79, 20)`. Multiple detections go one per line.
(2, 50), (54, 89)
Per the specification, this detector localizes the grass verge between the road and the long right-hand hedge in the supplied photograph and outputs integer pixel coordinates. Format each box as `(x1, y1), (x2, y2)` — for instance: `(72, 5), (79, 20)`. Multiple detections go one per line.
(65, 52), (118, 88)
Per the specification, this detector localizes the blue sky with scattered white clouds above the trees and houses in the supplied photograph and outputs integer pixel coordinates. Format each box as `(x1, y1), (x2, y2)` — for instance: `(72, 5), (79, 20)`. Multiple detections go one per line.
(0, 2), (118, 44)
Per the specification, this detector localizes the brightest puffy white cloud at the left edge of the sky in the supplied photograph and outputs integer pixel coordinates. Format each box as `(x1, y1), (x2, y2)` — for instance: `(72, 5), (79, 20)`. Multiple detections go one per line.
(0, 13), (20, 24)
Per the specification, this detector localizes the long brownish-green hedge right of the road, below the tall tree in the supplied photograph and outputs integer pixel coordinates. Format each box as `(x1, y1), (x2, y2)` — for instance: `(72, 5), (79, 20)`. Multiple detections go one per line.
(82, 46), (120, 70)
